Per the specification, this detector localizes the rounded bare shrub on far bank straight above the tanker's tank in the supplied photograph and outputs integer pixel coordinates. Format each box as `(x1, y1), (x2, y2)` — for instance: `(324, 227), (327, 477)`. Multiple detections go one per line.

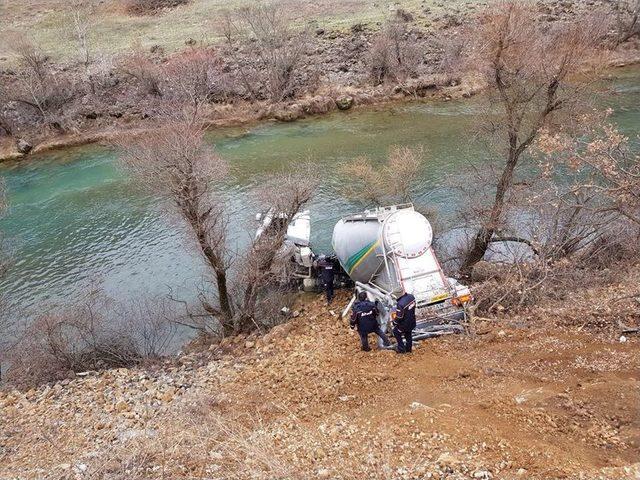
(366, 19), (422, 85)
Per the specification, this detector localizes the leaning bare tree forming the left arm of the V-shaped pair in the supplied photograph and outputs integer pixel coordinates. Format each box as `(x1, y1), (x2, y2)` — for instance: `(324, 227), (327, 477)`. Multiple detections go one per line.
(118, 108), (234, 334)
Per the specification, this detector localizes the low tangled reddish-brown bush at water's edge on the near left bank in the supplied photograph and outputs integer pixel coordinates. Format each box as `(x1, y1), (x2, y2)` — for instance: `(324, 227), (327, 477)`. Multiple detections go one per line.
(3, 294), (175, 388)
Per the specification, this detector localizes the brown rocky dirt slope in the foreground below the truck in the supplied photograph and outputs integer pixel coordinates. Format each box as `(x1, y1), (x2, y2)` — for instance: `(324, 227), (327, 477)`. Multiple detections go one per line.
(0, 274), (640, 479)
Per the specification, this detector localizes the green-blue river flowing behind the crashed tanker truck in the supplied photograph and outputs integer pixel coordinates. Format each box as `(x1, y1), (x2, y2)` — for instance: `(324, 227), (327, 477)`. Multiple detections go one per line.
(0, 68), (640, 322)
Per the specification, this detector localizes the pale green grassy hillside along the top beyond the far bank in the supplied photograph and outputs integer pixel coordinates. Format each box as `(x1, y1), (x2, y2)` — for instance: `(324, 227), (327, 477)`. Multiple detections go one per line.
(0, 0), (470, 60)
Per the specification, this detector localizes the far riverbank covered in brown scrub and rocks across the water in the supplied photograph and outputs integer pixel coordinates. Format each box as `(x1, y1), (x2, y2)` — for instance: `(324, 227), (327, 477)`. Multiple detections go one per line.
(0, 0), (640, 161)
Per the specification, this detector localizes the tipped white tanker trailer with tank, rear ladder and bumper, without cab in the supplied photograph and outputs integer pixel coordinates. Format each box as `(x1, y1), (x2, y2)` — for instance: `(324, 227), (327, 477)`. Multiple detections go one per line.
(332, 204), (471, 340)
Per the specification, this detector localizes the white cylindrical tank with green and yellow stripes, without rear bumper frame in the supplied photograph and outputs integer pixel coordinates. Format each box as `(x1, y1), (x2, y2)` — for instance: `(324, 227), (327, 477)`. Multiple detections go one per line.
(333, 205), (450, 302)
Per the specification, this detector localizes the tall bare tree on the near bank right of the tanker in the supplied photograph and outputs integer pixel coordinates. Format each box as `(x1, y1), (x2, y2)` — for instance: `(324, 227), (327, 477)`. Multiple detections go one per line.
(461, 1), (602, 276)
